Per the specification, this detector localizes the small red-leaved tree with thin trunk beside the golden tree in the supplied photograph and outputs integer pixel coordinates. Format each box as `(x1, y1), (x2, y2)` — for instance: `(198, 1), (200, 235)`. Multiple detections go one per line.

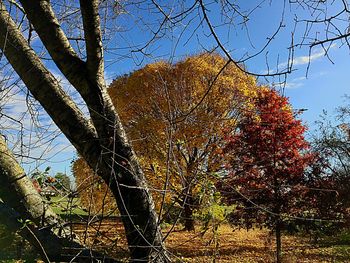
(219, 88), (315, 262)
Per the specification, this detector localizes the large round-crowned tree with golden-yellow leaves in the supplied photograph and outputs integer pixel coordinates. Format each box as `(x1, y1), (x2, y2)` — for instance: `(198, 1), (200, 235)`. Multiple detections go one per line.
(109, 53), (257, 230)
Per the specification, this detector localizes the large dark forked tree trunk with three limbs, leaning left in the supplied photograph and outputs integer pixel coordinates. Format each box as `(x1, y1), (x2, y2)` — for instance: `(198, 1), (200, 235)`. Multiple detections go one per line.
(0, 0), (168, 262)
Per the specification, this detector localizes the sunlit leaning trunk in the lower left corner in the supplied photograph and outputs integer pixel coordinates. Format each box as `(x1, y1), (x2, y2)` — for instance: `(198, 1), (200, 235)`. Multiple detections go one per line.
(0, 135), (114, 262)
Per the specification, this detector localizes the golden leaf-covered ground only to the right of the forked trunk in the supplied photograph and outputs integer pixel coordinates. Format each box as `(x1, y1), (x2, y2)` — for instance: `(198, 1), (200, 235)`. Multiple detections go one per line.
(167, 225), (350, 263)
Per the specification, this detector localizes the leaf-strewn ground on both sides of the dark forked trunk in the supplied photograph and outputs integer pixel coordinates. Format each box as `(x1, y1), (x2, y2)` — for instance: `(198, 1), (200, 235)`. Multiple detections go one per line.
(0, 220), (350, 263)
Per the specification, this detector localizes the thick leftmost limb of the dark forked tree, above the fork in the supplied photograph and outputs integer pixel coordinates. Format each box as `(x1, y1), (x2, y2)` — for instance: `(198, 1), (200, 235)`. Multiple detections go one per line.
(0, 1), (100, 161)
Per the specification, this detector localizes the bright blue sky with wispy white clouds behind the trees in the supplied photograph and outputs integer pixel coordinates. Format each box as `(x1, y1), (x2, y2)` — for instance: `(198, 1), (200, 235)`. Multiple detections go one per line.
(9, 1), (350, 177)
